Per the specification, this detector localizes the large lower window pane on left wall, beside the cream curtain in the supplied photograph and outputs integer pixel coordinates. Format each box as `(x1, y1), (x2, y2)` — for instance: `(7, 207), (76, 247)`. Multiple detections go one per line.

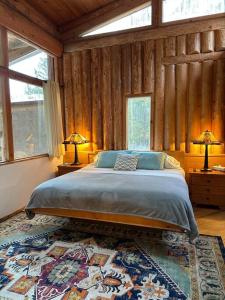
(10, 80), (48, 159)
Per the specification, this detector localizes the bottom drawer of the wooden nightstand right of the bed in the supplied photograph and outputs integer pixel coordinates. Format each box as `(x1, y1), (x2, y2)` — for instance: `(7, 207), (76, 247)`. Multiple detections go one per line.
(191, 193), (225, 206)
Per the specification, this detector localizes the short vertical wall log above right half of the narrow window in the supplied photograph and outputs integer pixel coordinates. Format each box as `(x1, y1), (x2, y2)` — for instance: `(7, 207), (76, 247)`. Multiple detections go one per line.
(142, 40), (155, 93)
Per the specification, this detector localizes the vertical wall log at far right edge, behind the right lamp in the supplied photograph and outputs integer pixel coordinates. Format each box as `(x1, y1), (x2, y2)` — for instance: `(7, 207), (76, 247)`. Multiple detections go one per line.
(212, 60), (225, 146)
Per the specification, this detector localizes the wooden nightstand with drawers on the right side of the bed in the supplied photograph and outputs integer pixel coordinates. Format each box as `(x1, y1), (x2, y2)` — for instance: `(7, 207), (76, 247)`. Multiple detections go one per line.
(189, 169), (225, 209)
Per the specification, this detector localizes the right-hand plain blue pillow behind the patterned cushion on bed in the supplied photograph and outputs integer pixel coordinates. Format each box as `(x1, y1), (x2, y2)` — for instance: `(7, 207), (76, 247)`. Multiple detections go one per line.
(132, 151), (166, 170)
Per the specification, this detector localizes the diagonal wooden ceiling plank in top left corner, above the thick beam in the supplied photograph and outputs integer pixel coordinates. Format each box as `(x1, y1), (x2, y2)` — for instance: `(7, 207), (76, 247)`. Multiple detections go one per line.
(1, 0), (59, 37)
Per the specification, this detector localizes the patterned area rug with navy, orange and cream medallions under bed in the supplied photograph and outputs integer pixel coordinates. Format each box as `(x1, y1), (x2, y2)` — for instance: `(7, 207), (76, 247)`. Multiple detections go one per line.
(0, 213), (225, 300)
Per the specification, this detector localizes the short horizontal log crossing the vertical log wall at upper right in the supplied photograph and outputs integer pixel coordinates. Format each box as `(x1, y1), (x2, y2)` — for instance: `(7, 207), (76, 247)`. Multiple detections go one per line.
(162, 52), (225, 65)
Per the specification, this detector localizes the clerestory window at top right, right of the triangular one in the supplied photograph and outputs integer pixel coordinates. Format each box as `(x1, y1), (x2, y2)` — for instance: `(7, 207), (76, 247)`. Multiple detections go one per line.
(163, 0), (225, 22)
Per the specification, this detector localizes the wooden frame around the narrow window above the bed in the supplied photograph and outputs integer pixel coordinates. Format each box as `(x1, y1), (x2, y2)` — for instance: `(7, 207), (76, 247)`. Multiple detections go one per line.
(123, 93), (154, 151)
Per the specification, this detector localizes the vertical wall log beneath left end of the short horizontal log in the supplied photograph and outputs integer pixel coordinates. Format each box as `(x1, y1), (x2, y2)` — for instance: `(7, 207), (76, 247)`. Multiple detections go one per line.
(164, 65), (176, 150)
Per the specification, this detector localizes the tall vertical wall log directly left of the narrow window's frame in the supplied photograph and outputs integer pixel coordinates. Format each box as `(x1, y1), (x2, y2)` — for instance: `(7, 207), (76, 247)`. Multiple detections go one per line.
(111, 45), (123, 149)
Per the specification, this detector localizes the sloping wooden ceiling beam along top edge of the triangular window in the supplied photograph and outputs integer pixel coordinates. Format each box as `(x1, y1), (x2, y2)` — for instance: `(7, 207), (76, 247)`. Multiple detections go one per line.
(60, 0), (151, 41)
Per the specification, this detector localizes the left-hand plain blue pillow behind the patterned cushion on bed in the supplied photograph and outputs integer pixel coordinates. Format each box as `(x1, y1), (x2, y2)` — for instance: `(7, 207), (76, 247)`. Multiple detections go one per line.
(95, 150), (132, 168)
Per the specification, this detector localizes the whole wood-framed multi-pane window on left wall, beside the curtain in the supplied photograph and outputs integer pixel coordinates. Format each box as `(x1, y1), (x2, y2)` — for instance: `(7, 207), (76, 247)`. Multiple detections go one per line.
(0, 28), (49, 161)
